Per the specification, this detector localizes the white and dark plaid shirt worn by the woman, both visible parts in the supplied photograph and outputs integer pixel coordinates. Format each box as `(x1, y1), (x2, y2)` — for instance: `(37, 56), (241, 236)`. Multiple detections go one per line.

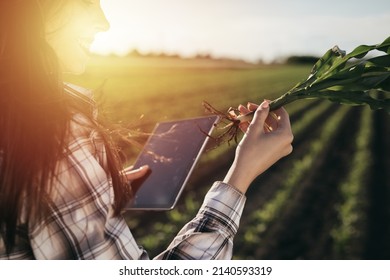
(0, 86), (245, 259)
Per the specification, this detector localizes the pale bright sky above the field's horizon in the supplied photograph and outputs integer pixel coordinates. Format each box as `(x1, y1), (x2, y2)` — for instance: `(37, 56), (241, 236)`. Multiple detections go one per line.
(91, 0), (390, 62)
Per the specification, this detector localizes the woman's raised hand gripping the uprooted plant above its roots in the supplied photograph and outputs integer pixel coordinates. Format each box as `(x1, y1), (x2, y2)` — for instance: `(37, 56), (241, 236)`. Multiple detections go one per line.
(224, 101), (293, 193)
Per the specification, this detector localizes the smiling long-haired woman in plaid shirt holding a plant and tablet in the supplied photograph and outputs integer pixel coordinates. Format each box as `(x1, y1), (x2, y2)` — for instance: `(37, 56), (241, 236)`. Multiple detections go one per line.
(0, 0), (292, 259)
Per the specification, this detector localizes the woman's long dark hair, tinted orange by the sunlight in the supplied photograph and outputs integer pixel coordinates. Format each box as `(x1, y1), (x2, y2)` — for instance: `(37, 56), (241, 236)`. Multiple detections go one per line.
(0, 0), (129, 251)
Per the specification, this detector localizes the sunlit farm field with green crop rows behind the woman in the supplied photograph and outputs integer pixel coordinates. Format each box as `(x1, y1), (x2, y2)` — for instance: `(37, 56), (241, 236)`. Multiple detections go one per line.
(65, 54), (390, 259)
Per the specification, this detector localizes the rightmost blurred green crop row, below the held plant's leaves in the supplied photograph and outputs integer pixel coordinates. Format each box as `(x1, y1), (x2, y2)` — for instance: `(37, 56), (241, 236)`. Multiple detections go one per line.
(331, 108), (373, 259)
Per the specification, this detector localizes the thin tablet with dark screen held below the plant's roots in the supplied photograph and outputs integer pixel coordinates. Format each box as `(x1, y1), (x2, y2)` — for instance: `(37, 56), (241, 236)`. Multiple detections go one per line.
(126, 116), (218, 210)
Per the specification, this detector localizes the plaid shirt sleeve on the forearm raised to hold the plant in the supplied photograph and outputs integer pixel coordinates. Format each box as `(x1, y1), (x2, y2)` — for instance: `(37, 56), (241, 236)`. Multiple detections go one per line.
(156, 182), (246, 260)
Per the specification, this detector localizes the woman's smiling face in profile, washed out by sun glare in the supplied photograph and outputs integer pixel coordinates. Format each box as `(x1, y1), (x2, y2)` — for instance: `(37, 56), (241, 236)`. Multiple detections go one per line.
(45, 0), (109, 74)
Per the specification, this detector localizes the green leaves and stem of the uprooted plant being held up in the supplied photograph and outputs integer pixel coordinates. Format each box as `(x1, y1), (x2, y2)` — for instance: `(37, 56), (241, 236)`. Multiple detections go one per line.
(270, 37), (390, 113)
